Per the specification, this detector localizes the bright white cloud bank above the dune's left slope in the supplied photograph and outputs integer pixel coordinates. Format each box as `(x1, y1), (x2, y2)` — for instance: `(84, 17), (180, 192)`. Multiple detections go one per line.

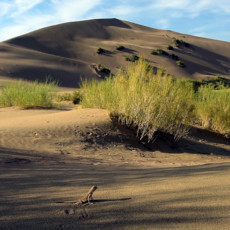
(0, 0), (101, 40)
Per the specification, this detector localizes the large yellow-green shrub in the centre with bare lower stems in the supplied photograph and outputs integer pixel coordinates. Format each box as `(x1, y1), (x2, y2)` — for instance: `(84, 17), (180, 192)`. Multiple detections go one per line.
(82, 59), (194, 141)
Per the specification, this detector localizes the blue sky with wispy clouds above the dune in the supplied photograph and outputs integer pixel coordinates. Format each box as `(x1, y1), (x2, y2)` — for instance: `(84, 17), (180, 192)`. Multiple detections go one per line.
(0, 0), (230, 42)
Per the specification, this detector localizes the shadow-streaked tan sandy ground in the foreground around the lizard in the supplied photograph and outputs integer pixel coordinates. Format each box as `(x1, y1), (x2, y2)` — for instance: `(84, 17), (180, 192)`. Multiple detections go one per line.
(0, 108), (230, 230)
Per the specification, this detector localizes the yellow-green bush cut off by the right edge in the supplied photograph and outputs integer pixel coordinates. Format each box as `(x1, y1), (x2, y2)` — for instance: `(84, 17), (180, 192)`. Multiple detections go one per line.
(196, 85), (230, 134)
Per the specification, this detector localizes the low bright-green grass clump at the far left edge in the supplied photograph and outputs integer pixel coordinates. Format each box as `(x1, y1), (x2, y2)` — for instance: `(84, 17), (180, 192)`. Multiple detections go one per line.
(0, 80), (57, 108)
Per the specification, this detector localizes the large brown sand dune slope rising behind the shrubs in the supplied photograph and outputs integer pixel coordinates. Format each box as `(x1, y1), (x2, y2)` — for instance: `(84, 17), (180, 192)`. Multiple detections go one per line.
(0, 19), (230, 87)
